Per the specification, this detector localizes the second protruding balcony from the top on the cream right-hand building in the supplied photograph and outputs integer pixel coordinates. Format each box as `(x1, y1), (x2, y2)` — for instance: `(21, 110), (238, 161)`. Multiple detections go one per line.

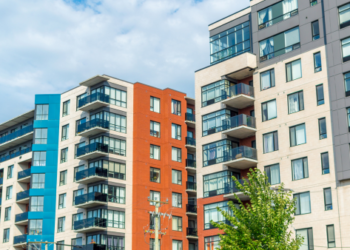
(222, 114), (256, 139)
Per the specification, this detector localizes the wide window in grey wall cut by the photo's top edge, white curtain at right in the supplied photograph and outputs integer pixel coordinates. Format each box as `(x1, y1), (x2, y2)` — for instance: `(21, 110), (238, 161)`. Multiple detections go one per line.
(258, 0), (298, 30)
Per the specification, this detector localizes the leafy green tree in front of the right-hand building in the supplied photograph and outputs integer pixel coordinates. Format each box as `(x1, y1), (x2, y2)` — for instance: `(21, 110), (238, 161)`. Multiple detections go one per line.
(211, 169), (303, 250)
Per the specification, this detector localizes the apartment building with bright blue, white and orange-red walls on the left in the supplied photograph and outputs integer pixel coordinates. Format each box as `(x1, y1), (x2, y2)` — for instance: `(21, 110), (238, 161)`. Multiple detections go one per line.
(0, 75), (198, 250)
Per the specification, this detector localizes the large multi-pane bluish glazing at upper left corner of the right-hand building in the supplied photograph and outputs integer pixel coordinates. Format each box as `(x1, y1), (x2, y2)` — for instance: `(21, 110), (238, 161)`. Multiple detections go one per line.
(210, 21), (250, 64)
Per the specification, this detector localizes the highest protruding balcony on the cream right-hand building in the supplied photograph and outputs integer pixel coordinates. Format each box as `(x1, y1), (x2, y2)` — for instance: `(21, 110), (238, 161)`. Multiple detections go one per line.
(222, 83), (255, 109)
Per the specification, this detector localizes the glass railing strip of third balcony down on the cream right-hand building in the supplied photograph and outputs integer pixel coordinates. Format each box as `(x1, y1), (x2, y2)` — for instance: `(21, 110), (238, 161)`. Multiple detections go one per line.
(203, 146), (257, 167)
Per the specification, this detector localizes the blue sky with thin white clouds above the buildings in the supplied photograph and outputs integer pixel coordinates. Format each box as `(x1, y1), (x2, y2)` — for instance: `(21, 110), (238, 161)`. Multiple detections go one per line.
(0, 0), (249, 123)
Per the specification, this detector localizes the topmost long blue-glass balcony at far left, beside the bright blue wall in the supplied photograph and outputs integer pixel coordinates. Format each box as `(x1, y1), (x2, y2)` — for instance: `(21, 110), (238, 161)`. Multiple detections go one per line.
(0, 125), (34, 151)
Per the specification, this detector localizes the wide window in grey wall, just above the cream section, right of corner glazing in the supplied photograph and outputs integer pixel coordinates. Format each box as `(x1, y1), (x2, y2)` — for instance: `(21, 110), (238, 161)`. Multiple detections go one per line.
(259, 27), (300, 62)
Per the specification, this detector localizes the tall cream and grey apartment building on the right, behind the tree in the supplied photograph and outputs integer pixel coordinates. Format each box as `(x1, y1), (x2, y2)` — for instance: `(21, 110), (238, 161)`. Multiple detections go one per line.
(195, 0), (350, 250)
